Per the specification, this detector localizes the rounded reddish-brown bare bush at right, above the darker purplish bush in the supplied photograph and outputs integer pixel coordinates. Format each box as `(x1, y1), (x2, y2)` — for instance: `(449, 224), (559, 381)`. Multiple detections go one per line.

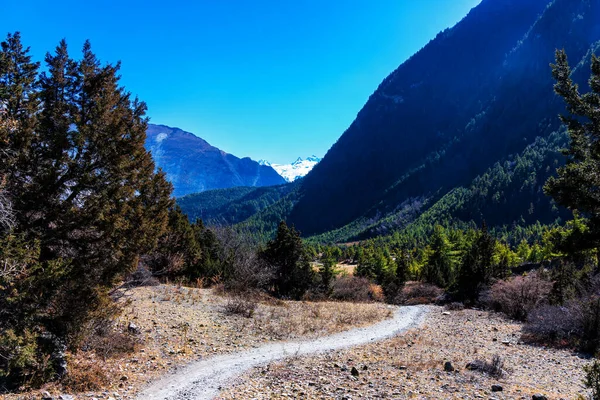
(481, 272), (552, 320)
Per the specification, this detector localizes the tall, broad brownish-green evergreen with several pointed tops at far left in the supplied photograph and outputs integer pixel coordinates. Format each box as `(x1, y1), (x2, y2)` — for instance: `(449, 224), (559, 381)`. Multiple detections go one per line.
(0, 34), (172, 388)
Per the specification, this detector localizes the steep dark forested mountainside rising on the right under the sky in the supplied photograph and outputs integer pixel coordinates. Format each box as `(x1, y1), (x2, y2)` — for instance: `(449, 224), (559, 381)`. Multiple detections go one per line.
(183, 0), (600, 241)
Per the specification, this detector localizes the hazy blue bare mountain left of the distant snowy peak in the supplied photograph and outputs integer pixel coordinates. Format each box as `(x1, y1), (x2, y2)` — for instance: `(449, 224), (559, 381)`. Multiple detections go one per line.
(146, 124), (285, 197)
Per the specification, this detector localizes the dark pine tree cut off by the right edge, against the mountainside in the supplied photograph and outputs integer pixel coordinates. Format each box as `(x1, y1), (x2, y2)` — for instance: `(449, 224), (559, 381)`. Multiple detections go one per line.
(544, 50), (600, 261)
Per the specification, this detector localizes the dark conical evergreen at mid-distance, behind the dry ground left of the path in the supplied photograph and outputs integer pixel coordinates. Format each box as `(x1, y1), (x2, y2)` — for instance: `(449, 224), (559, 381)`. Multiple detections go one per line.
(261, 221), (313, 299)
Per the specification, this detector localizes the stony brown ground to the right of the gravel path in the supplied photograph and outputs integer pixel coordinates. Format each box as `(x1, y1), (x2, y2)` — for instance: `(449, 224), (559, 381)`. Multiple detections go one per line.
(219, 308), (590, 399)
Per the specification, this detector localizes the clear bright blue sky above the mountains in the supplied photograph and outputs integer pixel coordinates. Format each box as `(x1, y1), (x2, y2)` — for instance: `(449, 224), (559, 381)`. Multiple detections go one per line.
(0, 0), (480, 163)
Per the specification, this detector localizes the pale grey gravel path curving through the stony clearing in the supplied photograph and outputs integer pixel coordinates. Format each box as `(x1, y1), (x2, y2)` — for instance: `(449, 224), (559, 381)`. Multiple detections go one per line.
(138, 306), (428, 400)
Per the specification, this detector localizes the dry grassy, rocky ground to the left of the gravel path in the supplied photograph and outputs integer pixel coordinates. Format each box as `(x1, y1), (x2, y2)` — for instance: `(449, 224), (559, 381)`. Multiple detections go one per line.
(0, 285), (392, 400)
